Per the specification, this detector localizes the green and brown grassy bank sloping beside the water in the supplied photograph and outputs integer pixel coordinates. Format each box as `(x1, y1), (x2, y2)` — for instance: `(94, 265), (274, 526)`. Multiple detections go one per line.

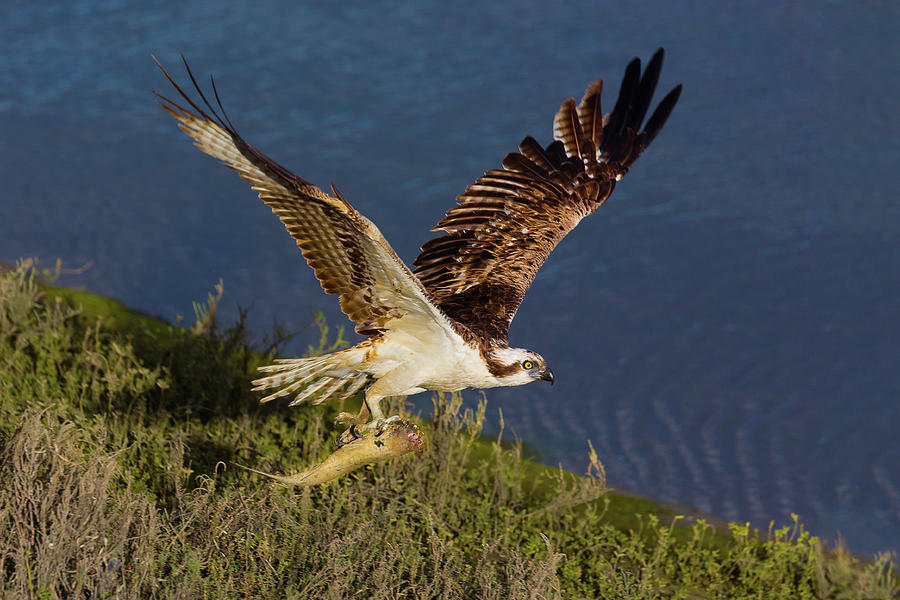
(0, 268), (898, 599)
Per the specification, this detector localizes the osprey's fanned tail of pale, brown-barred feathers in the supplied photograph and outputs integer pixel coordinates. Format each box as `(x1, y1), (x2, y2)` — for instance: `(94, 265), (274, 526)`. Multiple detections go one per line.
(253, 346), (372, 406)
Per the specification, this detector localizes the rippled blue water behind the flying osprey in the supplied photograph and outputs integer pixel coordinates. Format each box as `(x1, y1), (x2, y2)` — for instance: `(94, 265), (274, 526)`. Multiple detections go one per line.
(0, 0), (900, 553)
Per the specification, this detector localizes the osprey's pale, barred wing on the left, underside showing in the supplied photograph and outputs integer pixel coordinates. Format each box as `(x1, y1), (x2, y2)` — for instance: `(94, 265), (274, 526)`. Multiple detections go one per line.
(157, 61), (449, 335)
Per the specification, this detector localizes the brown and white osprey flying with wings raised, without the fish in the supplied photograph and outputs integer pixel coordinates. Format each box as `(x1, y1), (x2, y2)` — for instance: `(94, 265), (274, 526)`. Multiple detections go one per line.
(157, 48), (681, 433)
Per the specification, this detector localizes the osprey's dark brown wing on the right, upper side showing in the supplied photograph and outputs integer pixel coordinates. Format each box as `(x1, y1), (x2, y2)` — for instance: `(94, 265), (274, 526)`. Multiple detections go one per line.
(413, 48), (681, 339)
